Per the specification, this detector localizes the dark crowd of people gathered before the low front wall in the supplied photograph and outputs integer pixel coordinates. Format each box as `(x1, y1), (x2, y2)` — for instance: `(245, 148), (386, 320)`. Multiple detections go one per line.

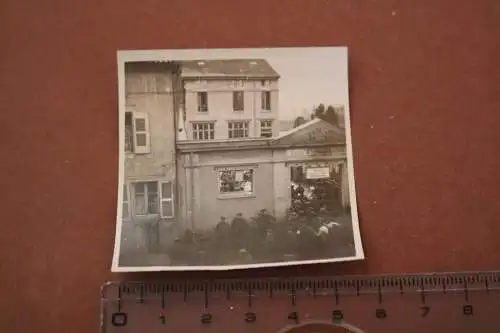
(168, 202), (348, 265)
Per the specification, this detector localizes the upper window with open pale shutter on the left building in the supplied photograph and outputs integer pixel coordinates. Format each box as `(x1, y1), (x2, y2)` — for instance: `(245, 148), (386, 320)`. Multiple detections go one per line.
(125, 112), (150, 154)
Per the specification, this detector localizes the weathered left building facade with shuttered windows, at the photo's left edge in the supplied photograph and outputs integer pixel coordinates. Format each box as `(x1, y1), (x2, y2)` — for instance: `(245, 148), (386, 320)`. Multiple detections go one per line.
(121, 62), (180, 254)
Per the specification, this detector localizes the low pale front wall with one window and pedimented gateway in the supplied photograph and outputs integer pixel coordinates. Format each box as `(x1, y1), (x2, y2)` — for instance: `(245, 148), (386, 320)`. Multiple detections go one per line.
(178, 119), (349, 229)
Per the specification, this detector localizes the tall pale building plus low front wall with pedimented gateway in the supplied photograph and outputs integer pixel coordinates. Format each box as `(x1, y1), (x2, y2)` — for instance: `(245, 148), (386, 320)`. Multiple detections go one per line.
(172, 59), (347, 229)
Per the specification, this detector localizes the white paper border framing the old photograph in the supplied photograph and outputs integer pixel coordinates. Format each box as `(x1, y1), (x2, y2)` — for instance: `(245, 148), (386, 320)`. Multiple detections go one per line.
(111, 46), (365, 273)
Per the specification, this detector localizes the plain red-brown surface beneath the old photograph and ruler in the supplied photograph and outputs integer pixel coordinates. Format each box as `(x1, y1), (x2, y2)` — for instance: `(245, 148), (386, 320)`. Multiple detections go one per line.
(0, 0), (500, 333)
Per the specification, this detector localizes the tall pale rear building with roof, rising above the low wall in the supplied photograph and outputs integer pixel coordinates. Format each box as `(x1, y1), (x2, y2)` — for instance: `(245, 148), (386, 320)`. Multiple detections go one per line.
(178, 59), (279, 141)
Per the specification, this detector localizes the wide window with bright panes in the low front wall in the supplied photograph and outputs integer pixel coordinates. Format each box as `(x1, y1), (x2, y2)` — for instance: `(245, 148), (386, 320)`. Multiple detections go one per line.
(218, 169), (253, 195)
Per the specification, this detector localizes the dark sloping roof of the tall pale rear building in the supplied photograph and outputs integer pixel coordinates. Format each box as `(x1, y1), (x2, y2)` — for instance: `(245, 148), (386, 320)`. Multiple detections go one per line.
(180, 59), (279, 79)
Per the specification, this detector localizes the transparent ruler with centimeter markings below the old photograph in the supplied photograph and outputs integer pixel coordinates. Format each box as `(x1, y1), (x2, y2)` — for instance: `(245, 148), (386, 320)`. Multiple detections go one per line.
(101, 272), (500, 333)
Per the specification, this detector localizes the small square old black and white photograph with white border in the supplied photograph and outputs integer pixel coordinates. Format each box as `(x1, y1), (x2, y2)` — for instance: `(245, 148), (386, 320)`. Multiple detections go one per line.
(112, 47), (364, 272)
